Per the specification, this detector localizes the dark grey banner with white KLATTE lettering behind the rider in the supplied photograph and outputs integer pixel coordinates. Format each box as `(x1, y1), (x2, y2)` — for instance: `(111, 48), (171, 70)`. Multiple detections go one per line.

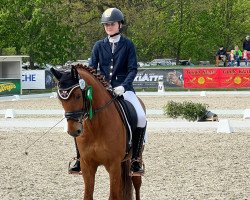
(133, 69), (183, 88)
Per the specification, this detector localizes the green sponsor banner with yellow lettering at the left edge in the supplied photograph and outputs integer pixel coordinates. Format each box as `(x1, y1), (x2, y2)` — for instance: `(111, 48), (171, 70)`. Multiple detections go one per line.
(0, 79), (21, 96)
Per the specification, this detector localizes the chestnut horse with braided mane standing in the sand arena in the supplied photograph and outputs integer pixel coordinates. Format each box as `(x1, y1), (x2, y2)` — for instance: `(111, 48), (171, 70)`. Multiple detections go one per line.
(51, 64), (145, 200)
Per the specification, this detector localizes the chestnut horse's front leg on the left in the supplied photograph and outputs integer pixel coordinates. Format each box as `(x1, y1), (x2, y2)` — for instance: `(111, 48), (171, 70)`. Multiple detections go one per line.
(81, 159), (97, 200)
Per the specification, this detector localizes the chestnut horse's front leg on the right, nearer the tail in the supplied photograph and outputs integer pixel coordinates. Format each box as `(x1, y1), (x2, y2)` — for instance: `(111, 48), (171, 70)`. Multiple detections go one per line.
(106, 160), (122, 200)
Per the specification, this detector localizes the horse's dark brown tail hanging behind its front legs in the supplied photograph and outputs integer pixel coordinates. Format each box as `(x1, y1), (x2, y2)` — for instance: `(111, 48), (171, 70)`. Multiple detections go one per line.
(121, 159), (133, 200)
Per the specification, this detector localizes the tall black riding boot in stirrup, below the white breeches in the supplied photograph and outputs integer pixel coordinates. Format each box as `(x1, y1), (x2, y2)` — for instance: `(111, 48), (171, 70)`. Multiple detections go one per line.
(131, 126), (146, 175)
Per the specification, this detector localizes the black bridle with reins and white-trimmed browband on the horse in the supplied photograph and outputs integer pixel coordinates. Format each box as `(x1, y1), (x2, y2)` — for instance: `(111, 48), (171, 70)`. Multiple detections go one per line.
(57, 79), (117, 124)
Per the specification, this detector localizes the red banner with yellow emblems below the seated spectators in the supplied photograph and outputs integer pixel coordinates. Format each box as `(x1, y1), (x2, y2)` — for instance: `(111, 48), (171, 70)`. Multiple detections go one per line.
(183, 67), (250, 88)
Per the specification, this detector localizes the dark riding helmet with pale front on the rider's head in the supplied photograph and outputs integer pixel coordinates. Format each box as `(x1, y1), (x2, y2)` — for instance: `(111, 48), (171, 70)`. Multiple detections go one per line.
(101, 8), (124, 24)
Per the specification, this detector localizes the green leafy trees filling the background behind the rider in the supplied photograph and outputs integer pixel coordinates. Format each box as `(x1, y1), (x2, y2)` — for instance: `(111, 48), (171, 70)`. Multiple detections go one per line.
(0, 0), (250, 67)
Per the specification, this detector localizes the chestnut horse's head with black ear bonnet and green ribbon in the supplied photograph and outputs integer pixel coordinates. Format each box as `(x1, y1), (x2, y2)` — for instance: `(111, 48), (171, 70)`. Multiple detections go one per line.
(51, 66), (92, 137)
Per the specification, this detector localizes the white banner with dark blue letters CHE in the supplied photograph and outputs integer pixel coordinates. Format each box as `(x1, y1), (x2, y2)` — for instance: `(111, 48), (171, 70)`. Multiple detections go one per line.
(22, 70), (45, 89)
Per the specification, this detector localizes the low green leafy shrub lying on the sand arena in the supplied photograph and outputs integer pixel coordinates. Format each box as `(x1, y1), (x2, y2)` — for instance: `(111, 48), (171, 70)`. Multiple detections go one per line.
(163, 101), (208, 121)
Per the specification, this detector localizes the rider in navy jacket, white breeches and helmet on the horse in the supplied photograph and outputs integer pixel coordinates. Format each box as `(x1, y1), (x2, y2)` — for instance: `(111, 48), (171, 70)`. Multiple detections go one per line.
(68, 8), (147, 175)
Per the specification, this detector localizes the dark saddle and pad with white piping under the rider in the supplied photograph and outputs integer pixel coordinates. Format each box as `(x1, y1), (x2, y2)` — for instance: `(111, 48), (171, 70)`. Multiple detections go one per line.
(115, 97), (138, 159)
